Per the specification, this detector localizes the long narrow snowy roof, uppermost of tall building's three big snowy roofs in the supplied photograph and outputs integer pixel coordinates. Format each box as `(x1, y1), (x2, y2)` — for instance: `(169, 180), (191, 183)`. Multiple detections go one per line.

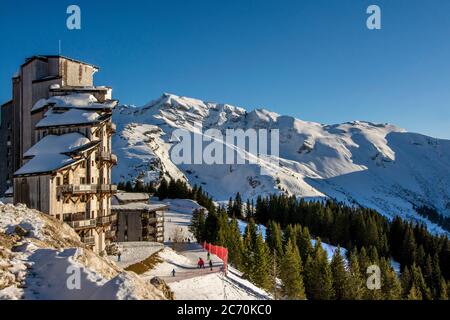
(31, 93), (117, 112)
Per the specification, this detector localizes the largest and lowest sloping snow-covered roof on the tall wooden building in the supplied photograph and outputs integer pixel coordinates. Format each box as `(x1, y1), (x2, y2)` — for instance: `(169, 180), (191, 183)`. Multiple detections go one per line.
(14, 133), (92, 176)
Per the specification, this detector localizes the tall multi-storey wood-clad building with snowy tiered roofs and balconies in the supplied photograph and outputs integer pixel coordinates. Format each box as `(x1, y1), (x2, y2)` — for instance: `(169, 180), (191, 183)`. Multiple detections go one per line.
(1, 56), (117, 253)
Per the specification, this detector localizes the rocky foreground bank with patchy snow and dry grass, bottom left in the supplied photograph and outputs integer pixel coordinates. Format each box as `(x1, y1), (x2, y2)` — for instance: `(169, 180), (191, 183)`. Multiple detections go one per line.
(0, 204), (165, 300)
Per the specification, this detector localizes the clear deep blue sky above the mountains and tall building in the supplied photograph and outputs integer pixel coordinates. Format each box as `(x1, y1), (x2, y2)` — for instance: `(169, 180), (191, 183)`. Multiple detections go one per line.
(0, 0), (450, 139)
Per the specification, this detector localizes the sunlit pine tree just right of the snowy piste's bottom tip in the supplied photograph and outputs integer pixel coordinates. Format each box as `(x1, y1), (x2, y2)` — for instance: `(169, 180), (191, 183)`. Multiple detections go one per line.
(280, 240), (306, 300)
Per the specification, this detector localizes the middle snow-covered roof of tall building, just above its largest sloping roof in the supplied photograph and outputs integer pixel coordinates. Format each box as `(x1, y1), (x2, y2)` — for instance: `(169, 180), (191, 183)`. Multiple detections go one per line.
(36, 109), (100, 128)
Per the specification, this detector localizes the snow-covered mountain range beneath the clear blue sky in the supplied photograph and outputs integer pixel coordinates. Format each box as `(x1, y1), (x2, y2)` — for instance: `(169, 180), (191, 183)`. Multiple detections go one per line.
(113, 94), (450, 232)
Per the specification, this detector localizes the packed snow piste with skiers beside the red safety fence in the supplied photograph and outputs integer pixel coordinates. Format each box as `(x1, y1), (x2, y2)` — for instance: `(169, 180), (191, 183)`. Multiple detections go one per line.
(135, 199), (270, 300)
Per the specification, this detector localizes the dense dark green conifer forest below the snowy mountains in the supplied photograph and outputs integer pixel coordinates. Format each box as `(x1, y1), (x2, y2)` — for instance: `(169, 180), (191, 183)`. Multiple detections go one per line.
(191, 194), (450, 299)
